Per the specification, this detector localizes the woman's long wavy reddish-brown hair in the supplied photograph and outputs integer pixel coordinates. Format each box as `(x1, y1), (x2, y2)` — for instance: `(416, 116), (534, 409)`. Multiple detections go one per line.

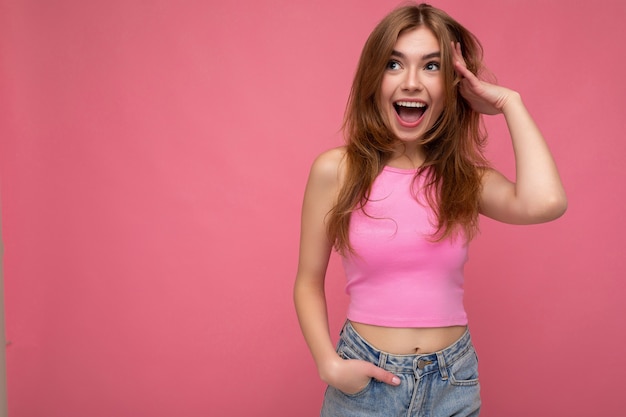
(327, 4), (488, 253)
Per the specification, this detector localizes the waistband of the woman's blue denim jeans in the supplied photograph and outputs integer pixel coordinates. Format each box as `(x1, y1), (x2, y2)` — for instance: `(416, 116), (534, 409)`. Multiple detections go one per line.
(341, 321), (474, 378)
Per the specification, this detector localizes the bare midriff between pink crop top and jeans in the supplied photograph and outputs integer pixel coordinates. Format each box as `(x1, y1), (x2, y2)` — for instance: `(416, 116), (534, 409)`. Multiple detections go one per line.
(350, 321), (467, 355)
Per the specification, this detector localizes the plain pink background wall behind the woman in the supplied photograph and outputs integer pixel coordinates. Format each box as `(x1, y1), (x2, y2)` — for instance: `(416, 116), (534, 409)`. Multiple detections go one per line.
(0, 0), (626, 417)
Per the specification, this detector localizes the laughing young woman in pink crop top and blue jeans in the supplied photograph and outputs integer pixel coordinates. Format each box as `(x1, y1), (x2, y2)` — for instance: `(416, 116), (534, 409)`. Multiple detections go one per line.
(294, 4), (567, 417)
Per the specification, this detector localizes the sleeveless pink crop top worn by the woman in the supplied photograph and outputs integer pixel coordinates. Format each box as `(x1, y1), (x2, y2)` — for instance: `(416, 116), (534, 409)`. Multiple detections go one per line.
(343, 167), (467, 327)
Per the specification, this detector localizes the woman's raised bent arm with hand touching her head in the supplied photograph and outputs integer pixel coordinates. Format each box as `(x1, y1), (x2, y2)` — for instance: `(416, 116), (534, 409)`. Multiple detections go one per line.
(454, 44), (567, 224)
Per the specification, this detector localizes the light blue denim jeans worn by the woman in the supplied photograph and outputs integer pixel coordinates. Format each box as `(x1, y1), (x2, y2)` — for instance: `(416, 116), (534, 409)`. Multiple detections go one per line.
(321, 322), (481, 417)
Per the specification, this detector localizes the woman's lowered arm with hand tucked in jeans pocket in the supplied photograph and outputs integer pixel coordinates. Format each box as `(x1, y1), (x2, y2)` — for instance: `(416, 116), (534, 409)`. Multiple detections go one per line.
(294, 148), (400, 393)
